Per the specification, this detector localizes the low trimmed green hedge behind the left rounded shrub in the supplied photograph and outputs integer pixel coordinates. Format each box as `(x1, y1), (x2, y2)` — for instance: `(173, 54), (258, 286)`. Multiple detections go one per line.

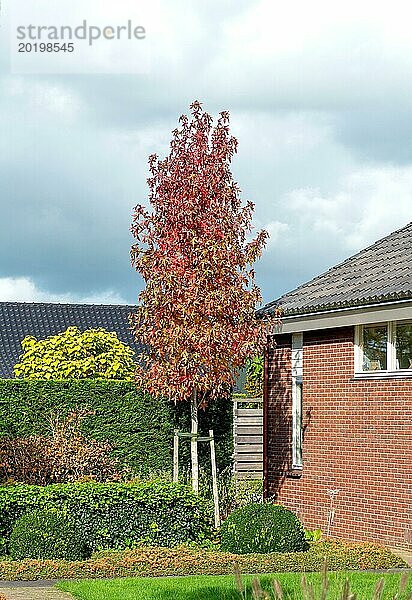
(0, 482), (212, 555)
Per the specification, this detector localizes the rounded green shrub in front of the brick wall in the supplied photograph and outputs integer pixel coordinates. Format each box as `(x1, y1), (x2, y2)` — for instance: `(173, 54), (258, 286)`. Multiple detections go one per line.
(221, 503), (308, 554)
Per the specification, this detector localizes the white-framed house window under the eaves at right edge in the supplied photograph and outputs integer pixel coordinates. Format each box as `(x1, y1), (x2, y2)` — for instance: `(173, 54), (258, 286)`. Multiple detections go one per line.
(355, 321), (412, 376)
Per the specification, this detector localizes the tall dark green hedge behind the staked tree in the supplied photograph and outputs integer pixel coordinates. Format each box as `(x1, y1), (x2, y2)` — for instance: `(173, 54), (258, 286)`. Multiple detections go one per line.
(0, 379), (233, 474)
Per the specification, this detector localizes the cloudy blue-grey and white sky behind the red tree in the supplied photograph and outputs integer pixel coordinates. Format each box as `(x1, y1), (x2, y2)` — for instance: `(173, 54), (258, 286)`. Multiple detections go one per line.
(0, 0), (412, 310)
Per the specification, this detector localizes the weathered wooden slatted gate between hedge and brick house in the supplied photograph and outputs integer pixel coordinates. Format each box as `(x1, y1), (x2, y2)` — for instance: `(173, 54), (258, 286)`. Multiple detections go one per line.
(233, 398), (263, 479)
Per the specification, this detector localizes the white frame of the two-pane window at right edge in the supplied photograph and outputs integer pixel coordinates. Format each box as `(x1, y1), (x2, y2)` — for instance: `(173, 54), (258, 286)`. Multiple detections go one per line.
(354, 319), (412, 379)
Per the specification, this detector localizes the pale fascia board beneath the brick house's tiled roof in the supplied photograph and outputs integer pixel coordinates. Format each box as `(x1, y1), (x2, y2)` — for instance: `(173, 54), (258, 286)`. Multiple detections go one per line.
(276, 300), (412, 334)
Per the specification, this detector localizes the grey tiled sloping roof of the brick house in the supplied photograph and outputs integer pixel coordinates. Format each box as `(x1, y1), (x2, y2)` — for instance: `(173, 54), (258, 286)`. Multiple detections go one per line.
(259, 218), (412, 316)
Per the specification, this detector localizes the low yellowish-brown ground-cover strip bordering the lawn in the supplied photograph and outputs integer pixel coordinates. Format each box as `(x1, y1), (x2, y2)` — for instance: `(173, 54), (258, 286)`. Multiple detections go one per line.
(0, 542), (407, 581)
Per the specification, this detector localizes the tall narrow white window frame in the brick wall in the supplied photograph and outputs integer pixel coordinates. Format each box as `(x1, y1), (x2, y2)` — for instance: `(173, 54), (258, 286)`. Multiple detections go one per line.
(292, 333), (303, 470)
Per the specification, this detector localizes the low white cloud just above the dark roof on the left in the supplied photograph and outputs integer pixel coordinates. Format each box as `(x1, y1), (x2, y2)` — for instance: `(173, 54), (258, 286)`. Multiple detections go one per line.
(0, 277), (126, 304)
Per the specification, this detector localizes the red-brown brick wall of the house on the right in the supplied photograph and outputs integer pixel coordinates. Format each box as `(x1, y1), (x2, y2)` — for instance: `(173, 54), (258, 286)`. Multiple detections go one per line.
(267, 327), (412, 547)
